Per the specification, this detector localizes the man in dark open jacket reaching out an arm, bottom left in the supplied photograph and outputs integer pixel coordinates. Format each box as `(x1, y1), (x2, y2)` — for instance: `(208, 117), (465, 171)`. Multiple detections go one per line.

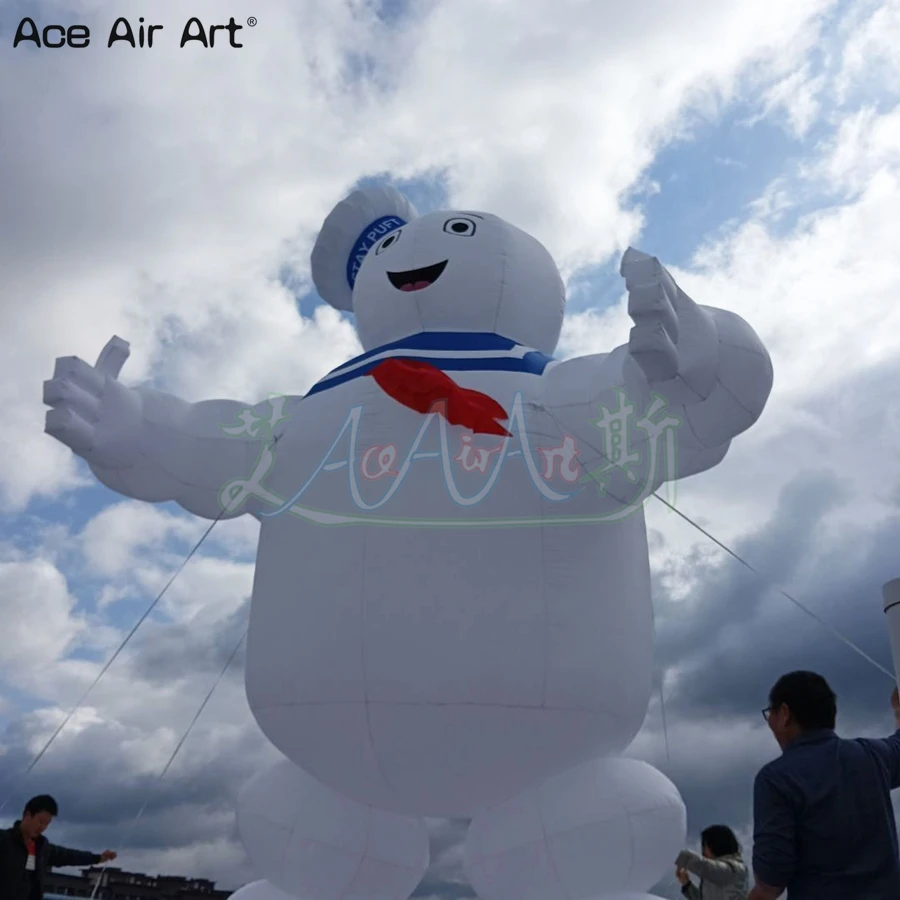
(0, 794), (116, 900)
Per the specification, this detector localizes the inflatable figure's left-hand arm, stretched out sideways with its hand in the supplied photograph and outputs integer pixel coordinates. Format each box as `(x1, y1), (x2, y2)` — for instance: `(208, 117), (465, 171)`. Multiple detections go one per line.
(44, 337), (287, 519)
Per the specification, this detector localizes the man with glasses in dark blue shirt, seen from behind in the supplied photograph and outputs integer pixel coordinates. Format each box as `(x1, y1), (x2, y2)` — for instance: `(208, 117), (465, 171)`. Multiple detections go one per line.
(750, 672), (900, 900)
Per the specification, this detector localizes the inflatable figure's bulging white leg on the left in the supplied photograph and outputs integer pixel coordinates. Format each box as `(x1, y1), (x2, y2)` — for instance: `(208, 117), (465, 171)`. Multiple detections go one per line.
(238, 760), (429, 900)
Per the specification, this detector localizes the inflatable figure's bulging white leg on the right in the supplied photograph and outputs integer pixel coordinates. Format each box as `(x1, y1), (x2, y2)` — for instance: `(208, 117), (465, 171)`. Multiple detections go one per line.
(465, 759), (687, 900)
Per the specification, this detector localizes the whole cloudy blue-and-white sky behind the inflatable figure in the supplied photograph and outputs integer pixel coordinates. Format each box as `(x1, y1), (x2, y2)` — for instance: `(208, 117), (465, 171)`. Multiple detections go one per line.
(0, 0), (900, 897)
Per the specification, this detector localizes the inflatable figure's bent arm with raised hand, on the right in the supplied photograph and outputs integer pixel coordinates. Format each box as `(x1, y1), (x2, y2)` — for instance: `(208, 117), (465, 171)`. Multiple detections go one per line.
(546, 248), (773, 486)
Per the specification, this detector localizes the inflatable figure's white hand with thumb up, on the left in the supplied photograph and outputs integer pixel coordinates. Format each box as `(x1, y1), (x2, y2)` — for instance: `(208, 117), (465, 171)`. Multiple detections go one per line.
(44, 337), (141, 468)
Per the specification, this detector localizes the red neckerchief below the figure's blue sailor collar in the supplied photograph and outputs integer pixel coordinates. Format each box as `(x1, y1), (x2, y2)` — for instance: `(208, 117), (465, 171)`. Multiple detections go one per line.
(369, 359), (512, 437)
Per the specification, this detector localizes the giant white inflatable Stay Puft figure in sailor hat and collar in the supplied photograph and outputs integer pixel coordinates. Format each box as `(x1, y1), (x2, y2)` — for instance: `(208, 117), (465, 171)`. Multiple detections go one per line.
(44, 188), (772, 900)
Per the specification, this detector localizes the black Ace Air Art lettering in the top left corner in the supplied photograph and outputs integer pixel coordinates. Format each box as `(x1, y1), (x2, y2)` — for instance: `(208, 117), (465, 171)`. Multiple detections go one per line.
(13, 16), (257, 50)
